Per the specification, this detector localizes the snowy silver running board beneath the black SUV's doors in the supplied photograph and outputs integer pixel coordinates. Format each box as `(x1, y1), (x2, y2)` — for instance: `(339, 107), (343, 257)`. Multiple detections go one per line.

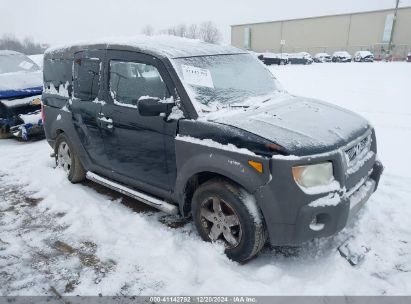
(86, 171), (178, 214)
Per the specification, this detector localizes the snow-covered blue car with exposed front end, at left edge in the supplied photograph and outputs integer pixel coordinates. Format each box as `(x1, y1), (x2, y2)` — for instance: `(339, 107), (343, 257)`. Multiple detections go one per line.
(0, 51), (44, 140)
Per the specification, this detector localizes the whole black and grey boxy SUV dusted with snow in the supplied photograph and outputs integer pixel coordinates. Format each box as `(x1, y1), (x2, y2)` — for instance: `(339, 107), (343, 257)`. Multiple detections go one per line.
(43, 37), (383, 262)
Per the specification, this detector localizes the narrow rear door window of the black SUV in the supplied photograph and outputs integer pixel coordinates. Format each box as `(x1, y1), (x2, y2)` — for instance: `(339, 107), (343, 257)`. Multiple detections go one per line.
(73, 58), (101, 100)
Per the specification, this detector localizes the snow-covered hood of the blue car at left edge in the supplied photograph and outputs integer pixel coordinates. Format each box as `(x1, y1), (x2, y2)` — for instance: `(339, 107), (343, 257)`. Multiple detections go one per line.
(0, 71), (43, 99)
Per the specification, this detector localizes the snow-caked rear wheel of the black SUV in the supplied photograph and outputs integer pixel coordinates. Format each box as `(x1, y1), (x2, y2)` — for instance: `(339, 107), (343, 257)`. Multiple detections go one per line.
(54, 133), (86, 183)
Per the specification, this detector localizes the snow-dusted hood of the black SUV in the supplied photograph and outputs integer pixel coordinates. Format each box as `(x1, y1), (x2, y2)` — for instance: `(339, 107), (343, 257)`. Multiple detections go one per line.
(213, 95), (371, 156)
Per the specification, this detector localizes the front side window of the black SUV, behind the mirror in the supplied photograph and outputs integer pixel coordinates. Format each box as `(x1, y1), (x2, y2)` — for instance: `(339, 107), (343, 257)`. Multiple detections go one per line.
(110, 60), (169, 107)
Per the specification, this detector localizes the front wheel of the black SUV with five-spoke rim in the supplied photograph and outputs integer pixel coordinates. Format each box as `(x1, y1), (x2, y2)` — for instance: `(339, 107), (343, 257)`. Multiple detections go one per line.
(192, 179), (267, 263)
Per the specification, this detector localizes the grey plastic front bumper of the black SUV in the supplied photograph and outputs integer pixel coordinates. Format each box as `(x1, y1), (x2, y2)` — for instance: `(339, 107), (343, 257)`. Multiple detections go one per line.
(255, 134), (383, 246)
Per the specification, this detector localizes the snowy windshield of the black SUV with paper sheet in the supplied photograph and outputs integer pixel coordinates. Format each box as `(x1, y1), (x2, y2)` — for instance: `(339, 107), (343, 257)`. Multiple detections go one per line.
(172, 54), (281, 112)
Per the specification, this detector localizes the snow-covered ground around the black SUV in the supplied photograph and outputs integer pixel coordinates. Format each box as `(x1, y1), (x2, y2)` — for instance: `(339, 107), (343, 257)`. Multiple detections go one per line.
(0, 63), (411, 295)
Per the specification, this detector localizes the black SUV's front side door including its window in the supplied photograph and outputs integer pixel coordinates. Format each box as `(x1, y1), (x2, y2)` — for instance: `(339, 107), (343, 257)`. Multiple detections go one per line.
(100, 50), (177, 191)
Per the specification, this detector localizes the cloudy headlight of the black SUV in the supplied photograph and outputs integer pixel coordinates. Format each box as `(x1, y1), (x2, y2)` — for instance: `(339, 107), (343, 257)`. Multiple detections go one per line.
(293, 162), (334, 188)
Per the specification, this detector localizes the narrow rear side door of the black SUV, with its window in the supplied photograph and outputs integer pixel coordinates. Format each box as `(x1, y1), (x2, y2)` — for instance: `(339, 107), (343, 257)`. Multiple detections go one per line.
(69, 51), (107, 167)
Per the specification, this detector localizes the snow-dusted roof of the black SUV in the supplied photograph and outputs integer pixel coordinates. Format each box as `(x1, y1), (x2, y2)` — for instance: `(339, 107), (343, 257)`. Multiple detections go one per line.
(44, 35), (247, 59)
